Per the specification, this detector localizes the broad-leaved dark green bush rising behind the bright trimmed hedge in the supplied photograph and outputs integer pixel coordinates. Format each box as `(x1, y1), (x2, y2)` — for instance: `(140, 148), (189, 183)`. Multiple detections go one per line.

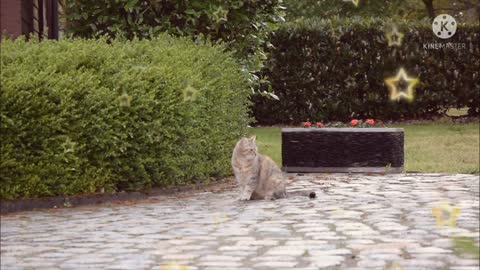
(66, 0), (284, 78)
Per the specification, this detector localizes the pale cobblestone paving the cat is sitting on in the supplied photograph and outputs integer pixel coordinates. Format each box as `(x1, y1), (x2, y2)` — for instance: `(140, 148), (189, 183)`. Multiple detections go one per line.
(0, 174), (480, 270)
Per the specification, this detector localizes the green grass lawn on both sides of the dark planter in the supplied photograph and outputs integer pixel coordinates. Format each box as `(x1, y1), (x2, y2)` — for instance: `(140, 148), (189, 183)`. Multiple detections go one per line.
(250, 121), (480, 174)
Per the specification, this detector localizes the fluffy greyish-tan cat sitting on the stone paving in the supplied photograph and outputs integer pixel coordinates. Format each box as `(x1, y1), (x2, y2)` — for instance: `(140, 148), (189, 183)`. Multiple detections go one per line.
(232, 136), (315, 200)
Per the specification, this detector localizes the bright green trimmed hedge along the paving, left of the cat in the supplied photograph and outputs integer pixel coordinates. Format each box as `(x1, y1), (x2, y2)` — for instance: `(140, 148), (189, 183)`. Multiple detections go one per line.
(0, 36), (250, 198)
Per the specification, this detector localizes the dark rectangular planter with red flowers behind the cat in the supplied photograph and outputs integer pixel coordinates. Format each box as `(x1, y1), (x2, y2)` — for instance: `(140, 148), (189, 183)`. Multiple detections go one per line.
(282, 128), (404, 173)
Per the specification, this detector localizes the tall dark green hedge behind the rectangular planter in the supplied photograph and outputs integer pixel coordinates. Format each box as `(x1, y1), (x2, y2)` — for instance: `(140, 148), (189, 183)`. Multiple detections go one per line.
(253, 19), (480, 125)
